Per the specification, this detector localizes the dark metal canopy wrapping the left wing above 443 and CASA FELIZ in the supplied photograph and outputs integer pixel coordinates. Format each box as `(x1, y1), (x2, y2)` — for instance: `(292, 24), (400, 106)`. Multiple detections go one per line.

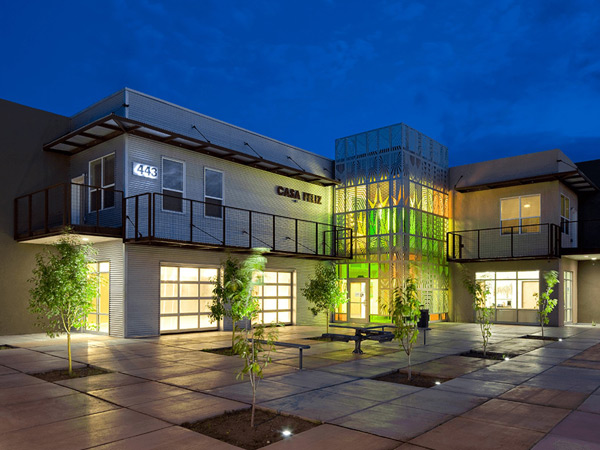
(44, 114), (340, 186)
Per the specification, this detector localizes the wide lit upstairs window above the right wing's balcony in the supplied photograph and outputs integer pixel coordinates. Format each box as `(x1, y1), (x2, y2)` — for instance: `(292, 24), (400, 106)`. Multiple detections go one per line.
(500, 194), (541, 234)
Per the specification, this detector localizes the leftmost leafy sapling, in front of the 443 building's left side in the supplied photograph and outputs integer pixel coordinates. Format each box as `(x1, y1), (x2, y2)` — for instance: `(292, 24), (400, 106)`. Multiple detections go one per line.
(29, 233), (98, 376)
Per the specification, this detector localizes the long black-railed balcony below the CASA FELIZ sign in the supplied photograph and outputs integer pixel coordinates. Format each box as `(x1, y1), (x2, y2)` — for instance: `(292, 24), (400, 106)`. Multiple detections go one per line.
(124, 193), (352, 259)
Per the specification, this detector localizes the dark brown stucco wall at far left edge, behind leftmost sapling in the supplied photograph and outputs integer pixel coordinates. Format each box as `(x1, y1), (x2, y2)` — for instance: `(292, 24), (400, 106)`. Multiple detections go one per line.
(0, 100), (69, 335)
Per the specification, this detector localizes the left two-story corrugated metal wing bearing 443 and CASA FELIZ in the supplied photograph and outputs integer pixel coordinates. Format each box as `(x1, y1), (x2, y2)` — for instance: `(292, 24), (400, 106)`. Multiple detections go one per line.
(0, 89), (352, 337)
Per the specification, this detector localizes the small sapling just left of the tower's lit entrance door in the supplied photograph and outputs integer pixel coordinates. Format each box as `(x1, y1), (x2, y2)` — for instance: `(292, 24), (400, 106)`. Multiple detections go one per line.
(302, 264), (348, 333)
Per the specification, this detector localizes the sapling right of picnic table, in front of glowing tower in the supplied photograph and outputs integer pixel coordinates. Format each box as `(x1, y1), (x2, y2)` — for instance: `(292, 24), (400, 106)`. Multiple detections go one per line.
(383, 277), (421, 380)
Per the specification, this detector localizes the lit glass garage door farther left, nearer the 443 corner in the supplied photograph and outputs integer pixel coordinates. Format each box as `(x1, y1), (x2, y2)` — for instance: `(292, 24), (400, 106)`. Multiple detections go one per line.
(160, 265), (219, 333)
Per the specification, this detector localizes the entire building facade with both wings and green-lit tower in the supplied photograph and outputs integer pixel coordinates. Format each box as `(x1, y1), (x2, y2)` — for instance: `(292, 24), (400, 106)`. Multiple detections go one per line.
(0, 89), (600, 337)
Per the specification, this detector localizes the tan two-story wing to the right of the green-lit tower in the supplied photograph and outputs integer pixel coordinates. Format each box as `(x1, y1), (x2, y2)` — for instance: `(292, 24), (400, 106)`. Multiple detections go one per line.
(447, 150), (600, 326)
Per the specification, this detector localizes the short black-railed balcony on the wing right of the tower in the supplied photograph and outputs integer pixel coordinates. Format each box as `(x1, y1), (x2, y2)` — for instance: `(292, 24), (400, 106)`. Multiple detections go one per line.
(446, 223), (561, 262)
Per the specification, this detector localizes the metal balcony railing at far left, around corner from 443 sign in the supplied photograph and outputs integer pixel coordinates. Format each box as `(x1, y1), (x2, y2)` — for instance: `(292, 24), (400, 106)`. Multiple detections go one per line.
(14, 183), (123, 240)
